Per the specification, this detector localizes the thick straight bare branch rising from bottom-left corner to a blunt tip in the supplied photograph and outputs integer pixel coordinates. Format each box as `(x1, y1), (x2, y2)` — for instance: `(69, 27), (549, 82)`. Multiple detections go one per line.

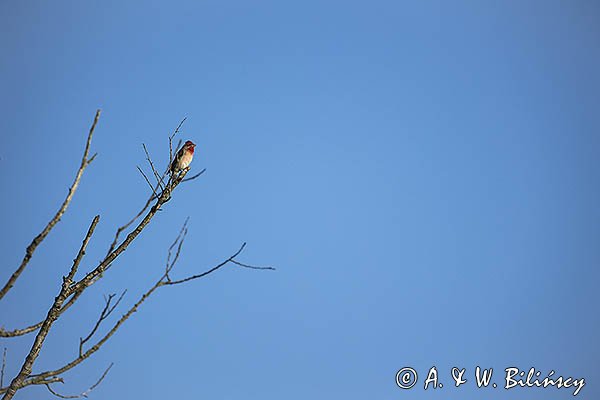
(2, 215), (100, 400)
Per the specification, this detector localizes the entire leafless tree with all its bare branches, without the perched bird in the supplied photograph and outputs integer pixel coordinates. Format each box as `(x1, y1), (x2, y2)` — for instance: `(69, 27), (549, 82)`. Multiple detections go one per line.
(0, 110), (274, 400)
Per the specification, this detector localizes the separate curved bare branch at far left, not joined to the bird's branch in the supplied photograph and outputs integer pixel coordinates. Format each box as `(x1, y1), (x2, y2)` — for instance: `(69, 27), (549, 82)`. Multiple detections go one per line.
(0, 110), (100, 299)
